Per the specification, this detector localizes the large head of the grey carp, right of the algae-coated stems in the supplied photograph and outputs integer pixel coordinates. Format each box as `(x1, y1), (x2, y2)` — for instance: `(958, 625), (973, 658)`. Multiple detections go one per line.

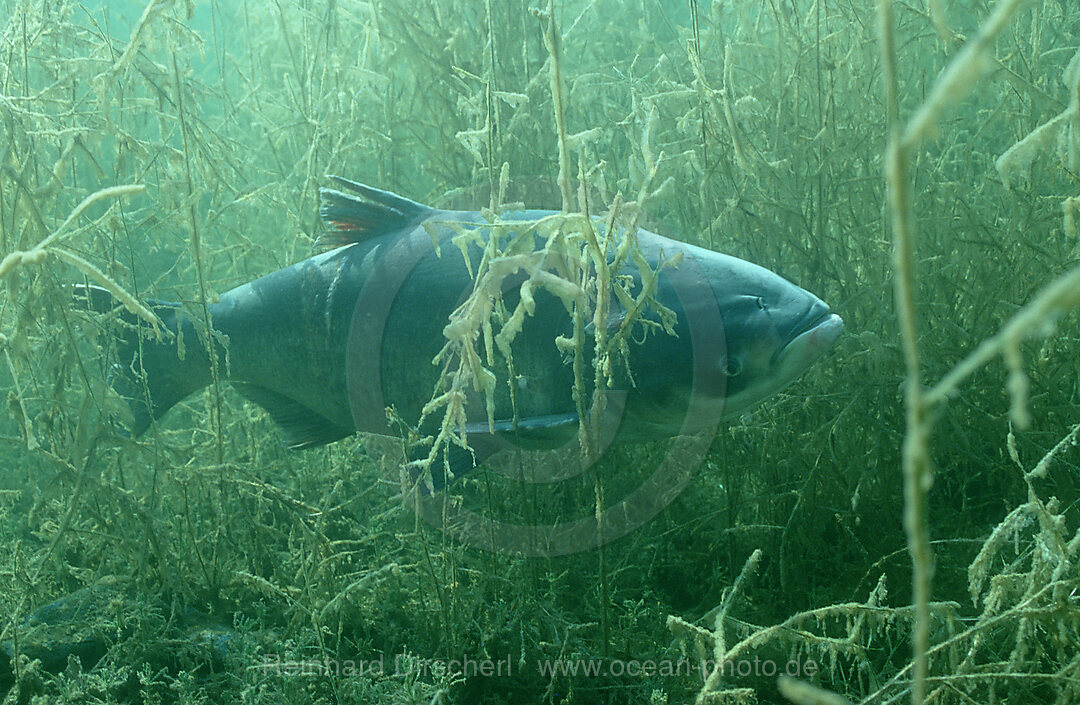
(632, 233), (843, 435)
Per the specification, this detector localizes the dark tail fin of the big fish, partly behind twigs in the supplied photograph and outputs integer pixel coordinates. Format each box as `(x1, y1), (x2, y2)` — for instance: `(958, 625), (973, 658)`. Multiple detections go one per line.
(71, 285), (212, 436)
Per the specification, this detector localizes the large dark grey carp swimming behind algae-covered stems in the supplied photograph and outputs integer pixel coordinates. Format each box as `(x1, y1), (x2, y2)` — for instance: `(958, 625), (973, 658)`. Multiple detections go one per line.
(89, 176), (843, 479)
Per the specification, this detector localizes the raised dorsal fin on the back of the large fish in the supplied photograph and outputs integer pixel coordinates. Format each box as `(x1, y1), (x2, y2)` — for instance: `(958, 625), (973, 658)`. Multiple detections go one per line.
(315, 176), (433, 249)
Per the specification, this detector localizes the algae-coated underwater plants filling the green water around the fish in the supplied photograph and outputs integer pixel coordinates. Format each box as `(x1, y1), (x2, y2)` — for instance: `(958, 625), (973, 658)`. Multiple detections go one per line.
(0, 0), (1080, 704)
